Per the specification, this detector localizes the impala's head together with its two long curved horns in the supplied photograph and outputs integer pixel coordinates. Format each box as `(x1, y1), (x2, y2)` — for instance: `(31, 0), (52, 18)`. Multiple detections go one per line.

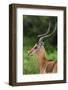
(28, 22), (56, 55)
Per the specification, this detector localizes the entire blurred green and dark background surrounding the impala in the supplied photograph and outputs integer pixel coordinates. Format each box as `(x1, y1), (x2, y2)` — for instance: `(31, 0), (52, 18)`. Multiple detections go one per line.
(23, 15), (57, 74)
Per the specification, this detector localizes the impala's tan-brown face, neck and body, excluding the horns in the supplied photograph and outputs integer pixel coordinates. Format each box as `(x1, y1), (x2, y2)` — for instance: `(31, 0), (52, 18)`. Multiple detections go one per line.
(29, 46), (57, 74)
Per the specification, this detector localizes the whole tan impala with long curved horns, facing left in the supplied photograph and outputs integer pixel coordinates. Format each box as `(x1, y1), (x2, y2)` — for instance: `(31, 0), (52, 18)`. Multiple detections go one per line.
(28, 23), (57, 74)
